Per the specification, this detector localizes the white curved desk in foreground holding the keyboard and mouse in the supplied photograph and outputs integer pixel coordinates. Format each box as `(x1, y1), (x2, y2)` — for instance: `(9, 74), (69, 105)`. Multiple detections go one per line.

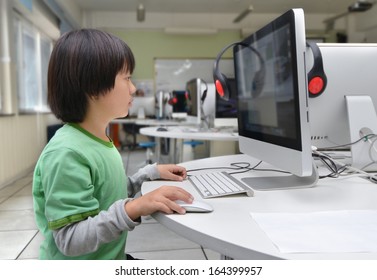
(142, 155), (377, 260)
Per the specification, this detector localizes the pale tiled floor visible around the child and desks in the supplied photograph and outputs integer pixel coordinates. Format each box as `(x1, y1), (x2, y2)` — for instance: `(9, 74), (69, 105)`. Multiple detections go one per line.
(0, 150), (220, 260)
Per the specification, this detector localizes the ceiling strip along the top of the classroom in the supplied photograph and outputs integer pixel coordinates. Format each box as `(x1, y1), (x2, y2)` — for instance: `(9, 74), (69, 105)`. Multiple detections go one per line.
(75, 0), (356, 14)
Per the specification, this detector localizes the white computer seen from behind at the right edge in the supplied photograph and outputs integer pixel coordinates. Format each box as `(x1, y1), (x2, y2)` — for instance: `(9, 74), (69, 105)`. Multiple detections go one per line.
(307, 43), (377, 170)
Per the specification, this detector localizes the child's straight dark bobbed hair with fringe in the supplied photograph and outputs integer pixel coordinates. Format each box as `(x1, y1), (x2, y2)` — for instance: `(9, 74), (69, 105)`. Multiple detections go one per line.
(47, 29), (135, 122)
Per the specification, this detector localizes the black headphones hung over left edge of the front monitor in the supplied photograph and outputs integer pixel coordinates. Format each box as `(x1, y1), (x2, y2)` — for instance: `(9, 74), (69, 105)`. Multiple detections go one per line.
(213, 42), (266, 100)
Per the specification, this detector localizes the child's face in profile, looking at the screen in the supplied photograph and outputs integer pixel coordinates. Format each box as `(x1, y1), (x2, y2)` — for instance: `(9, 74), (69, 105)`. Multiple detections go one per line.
(103, 72), (136, 119)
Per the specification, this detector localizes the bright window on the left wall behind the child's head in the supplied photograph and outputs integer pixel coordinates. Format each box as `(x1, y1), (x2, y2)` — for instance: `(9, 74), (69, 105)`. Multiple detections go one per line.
(14, 16), (52, 113)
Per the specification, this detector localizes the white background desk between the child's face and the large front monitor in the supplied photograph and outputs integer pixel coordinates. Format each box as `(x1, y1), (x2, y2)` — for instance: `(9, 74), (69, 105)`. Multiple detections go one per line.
(140, 125), (238, 162)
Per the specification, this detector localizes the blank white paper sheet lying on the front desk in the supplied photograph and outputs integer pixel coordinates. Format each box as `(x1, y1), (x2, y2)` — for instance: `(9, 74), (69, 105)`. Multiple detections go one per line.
(250, 210), (377, 253)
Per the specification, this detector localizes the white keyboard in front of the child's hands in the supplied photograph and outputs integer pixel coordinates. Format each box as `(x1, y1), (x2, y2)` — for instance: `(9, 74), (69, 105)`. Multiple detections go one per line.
(188, 172), (254, 198)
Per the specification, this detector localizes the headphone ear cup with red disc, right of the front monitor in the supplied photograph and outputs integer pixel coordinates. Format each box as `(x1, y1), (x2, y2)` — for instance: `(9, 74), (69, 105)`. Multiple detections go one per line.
(306, 42), (327, 97)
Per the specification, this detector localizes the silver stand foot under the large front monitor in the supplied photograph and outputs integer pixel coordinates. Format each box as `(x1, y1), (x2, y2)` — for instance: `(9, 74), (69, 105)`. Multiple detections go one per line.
(241, 160), (319, 191)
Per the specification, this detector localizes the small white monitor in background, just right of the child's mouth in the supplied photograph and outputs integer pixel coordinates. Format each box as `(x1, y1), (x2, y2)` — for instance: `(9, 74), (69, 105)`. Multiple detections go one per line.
(128, 96), (156, 118)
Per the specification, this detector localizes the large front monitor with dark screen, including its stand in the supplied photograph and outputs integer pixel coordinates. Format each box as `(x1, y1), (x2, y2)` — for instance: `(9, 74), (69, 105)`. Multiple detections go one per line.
(233, 9), (318, 190)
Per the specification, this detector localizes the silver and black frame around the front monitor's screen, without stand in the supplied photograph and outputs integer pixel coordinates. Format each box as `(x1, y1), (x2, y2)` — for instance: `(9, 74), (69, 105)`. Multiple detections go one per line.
(233, 9), (313, 176)
